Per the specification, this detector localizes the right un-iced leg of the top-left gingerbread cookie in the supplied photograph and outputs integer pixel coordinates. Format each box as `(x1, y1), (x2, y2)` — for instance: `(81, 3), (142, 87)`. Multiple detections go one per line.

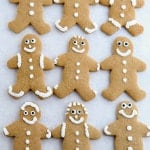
(31, 18), (51, 34)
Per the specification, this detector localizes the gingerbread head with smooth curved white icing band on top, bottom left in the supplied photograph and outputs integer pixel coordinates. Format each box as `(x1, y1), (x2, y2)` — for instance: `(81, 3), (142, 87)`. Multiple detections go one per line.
(20, 102), (41, 125)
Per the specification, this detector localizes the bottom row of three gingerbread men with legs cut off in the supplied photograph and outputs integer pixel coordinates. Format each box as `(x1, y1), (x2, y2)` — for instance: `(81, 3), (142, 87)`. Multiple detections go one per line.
(3, 101), (150, 150)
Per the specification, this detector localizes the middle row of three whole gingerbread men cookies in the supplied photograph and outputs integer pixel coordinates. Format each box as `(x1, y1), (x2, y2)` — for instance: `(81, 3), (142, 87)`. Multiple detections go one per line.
(7, 34), (146, 101)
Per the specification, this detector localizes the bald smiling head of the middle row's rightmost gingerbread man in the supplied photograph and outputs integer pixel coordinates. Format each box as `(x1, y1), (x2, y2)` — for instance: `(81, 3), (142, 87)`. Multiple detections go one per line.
(113, 37), (133, 57)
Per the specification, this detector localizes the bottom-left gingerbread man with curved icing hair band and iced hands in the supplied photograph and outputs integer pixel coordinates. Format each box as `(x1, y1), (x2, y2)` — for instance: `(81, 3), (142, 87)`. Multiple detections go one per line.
(3, 102), (51, 150)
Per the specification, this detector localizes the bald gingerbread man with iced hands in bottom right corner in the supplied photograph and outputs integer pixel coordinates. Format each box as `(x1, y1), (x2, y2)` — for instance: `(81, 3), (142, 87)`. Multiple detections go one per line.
(104, 101), (150, 150)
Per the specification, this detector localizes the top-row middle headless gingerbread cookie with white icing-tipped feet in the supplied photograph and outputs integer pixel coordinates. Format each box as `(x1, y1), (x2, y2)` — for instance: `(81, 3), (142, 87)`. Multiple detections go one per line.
(54, 0), (99, 33)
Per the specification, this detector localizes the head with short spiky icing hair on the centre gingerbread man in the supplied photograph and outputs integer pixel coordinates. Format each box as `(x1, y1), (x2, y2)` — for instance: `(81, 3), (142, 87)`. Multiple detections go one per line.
(69, 36), (89, 54)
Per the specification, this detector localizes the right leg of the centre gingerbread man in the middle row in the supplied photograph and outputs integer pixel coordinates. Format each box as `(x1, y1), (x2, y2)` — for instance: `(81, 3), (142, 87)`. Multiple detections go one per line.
(76, 84), (96, 101)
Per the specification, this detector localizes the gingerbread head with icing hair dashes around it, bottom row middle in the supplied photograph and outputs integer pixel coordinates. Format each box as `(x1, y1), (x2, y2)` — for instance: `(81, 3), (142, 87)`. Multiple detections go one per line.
(66, 102), (88, 124)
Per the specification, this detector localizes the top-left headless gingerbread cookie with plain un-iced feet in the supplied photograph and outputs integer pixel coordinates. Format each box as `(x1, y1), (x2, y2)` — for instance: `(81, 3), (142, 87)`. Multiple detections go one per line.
(8, 0), (52, 34)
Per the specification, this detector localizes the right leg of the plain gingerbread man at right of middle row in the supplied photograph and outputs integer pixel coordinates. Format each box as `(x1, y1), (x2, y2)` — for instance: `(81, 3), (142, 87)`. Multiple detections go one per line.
(126, 86), (146, 101)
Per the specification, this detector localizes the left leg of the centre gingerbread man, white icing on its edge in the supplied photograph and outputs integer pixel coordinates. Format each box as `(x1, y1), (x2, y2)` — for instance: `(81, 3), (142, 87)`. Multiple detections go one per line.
(53, 82), (74, 98)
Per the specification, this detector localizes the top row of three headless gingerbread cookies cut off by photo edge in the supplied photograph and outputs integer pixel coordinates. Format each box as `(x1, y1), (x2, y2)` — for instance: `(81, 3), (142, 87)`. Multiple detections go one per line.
(8, 0), (144, 36)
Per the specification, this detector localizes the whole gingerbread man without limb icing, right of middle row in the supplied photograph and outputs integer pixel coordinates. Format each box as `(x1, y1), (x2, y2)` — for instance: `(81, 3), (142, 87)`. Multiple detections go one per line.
(101, 37), (146, 101)
